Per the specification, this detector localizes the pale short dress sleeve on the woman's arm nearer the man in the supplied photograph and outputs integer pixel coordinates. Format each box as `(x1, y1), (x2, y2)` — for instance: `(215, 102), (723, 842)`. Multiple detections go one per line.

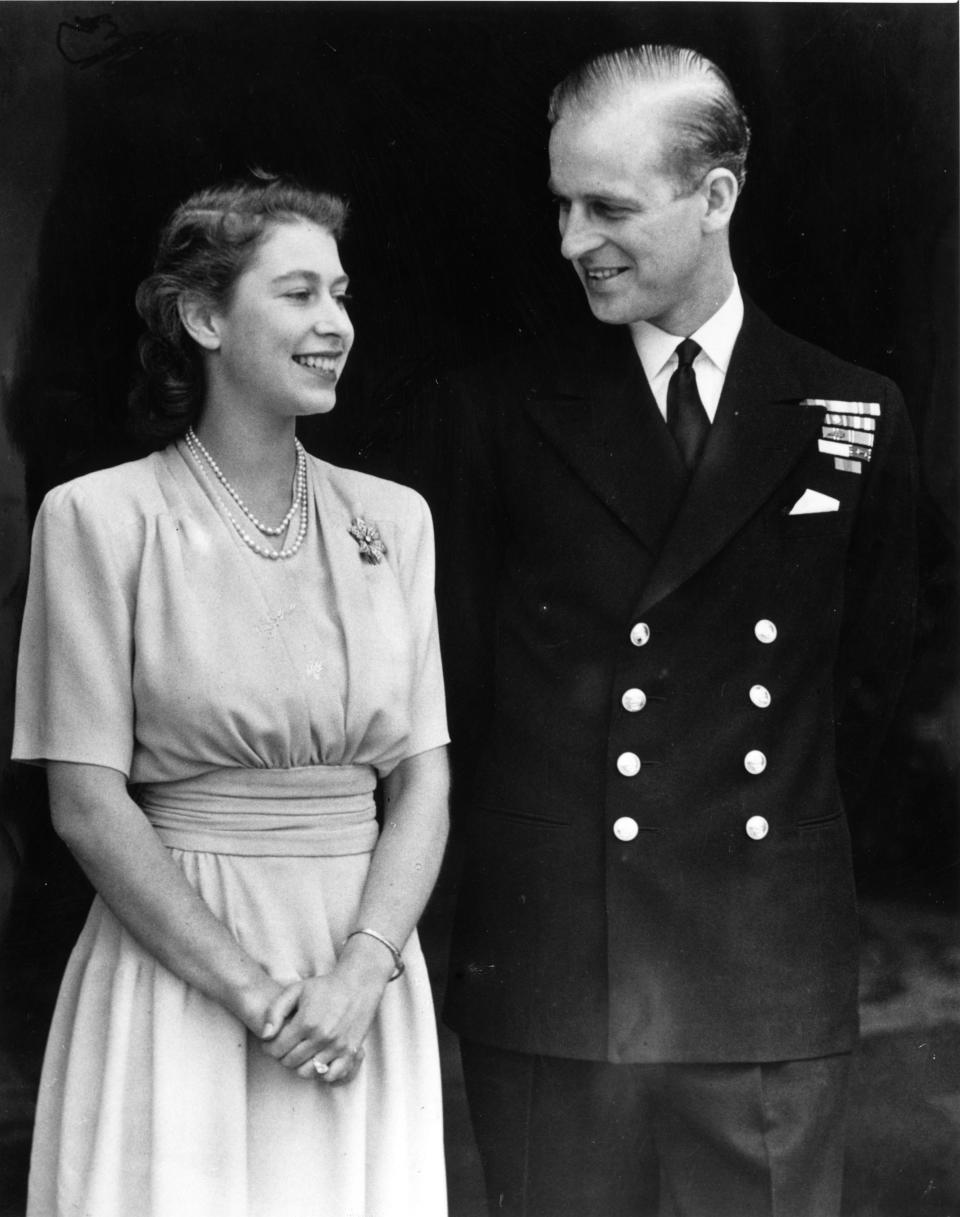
(400, 495), (450, 757)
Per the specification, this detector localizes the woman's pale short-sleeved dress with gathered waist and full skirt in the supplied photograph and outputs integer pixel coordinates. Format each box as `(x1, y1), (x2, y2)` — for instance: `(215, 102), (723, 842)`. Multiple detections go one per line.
(15, 444), (448, 1217)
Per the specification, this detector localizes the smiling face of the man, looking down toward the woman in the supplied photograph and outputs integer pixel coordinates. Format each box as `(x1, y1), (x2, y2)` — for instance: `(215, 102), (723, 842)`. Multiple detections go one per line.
(550, 89), (709, 333)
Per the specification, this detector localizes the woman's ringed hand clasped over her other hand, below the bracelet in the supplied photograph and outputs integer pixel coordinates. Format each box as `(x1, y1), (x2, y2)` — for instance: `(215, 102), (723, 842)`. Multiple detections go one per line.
(257, 943), (393, 1083)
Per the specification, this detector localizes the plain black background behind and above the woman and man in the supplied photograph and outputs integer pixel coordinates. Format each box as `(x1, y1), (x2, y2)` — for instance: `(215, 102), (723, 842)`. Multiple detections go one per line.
(0, 2), (960, 1207)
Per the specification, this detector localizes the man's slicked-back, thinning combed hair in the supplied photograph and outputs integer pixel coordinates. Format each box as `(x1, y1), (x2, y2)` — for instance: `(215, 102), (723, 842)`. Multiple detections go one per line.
(548, 44), (750, 192)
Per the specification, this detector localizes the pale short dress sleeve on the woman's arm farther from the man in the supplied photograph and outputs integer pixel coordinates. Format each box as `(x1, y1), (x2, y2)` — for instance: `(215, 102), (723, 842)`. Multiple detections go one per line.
(13, 487), (134, 776)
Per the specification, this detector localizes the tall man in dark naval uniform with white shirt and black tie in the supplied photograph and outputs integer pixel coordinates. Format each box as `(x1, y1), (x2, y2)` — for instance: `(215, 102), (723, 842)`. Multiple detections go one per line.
(442, 46), (915, 1217)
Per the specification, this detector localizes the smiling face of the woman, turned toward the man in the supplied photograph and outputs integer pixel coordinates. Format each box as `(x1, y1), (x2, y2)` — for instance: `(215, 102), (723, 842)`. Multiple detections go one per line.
(204, 220), (353, 417)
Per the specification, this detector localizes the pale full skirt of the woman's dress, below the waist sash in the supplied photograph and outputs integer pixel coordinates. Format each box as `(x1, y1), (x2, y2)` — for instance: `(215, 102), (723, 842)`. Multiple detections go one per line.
(27, 769), (447, 1217)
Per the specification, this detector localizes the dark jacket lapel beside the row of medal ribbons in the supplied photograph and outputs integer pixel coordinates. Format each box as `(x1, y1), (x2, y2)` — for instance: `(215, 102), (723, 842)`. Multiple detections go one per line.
(638, 304), (823, 612)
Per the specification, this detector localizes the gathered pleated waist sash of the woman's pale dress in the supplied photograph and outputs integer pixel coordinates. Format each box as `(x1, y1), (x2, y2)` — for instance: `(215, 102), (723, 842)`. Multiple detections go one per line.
(136, 765), (378, 857)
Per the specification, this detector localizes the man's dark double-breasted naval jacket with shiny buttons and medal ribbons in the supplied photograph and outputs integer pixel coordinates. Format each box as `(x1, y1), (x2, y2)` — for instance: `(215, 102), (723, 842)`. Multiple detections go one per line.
(440, 303), (915, 1062)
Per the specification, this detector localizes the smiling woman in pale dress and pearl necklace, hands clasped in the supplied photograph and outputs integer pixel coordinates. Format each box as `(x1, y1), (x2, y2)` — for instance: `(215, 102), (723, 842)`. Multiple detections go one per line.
(15, 180), (448, 1217)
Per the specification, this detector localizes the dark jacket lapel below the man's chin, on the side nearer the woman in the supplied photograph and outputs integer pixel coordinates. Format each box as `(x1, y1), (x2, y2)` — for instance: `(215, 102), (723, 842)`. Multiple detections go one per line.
(526, 326), (686, 553)
